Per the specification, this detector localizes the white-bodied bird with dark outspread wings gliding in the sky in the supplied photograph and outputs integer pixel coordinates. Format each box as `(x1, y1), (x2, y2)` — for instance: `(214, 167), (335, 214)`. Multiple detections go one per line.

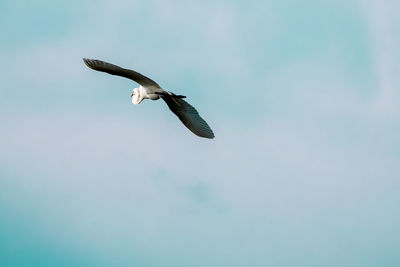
(83, 58), (214, 139)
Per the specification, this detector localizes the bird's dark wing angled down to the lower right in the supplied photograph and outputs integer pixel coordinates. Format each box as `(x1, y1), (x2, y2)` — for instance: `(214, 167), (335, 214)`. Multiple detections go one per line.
(162, 95), (214, 138)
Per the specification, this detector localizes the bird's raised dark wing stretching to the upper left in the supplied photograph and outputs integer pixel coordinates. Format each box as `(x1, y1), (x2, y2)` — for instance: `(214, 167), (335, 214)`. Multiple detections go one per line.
(83, 58), (160, 88)
